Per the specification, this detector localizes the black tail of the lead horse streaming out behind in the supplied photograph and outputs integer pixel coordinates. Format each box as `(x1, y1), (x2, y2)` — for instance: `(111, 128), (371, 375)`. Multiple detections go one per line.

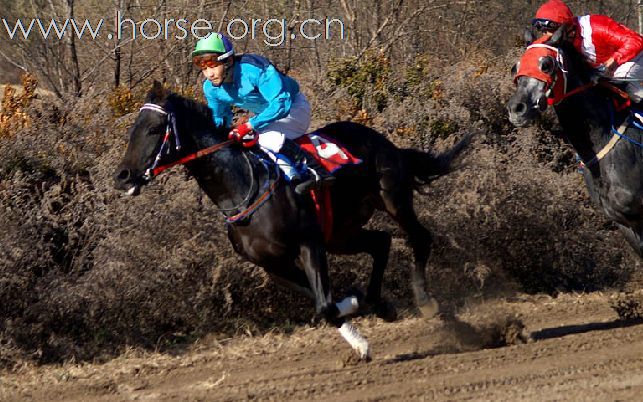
(401, 134), (471, 188)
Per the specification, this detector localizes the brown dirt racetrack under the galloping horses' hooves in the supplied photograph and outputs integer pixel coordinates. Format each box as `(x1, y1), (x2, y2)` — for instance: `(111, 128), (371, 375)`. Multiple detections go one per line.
(0, 293), (643, 401)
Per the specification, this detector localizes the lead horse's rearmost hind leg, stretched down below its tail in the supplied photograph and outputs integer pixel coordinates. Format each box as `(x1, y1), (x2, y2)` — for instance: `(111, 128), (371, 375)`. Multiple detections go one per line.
(380, 187), (438, 318)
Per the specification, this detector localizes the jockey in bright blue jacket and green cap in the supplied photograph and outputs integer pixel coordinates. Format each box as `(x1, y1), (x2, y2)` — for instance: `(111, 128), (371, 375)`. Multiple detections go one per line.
(192, 33), (334, 194)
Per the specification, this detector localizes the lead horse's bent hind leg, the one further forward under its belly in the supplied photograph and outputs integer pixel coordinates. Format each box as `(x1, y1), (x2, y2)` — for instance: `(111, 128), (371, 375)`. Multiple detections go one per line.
(331, 229), (397, 321)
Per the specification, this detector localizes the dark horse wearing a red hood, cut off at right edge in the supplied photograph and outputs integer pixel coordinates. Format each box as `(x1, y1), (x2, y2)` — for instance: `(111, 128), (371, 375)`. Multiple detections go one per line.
(507, 28), (643, 258)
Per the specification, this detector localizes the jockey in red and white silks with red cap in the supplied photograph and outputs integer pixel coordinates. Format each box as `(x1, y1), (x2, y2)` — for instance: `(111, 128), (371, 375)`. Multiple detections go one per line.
(532, 0), (643, 102)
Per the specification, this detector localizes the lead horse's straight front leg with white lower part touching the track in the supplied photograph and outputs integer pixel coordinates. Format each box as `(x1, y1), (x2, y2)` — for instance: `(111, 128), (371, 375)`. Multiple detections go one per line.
(299, 242), (370, 360)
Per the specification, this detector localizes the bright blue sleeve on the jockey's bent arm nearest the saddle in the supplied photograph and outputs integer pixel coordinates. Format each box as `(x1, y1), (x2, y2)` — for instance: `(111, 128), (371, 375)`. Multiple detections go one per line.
(249, 65), (292, 130)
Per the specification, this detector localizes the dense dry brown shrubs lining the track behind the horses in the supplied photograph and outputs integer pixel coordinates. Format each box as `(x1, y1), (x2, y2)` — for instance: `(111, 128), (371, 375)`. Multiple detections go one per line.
(0, 48), (634, 366)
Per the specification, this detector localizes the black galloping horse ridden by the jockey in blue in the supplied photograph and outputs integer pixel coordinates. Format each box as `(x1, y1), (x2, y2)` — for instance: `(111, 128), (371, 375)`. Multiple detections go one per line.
(115, 83), (468, 358)
